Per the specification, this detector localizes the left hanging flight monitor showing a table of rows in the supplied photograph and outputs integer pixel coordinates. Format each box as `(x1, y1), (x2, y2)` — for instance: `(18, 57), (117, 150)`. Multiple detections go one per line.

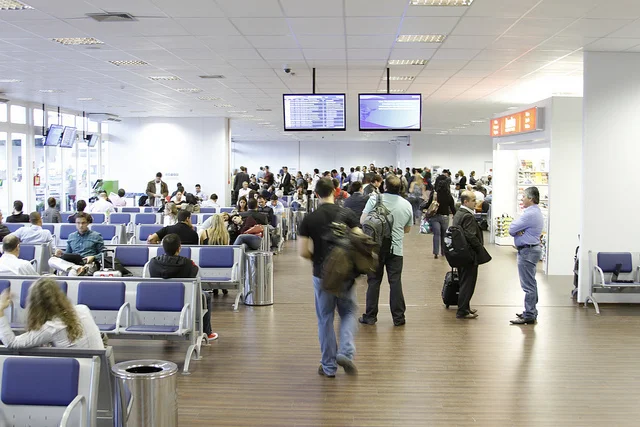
(283, 93), (347, 131)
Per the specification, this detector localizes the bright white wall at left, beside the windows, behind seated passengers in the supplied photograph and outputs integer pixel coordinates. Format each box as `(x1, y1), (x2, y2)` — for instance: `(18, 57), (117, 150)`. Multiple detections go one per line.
(105, 117), (229, 205)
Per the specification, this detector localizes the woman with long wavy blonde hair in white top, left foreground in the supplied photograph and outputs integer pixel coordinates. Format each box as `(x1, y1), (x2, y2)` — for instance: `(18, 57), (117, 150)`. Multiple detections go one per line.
(0, 277), (104, 350)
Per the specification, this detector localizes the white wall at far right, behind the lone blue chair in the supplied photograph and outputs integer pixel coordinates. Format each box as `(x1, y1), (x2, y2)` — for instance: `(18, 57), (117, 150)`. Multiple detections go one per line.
(576, 52), (640, 302)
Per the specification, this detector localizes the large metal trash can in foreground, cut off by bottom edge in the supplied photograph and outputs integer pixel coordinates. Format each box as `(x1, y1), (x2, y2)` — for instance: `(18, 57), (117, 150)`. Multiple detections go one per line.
(111, 360), (178, 427)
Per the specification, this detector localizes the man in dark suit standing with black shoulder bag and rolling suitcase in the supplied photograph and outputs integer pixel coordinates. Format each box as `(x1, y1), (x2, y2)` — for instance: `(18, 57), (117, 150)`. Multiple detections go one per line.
(453, 191), (485, 319)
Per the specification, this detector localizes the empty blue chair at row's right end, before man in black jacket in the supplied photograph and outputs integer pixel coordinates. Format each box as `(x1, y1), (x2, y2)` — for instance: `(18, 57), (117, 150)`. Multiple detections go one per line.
(123, 282), (191, 335)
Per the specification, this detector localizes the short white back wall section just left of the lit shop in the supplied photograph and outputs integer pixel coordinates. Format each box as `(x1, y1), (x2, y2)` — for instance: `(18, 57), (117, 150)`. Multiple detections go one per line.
(411, 135), (493, 178)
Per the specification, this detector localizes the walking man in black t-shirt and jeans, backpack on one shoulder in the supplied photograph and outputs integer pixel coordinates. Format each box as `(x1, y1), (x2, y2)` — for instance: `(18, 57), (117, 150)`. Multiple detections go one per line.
(298, 178), (360, 378)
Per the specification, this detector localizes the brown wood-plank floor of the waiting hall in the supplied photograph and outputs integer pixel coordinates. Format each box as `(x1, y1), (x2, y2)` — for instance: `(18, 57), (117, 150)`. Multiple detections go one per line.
(111, 232), (640, 427)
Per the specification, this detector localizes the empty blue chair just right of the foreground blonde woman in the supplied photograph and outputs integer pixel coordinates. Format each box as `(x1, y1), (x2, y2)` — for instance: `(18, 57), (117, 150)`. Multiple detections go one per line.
(78, 281), (128, 332)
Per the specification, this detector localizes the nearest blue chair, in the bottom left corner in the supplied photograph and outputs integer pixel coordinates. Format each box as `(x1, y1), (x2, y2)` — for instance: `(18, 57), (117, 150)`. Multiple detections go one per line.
(0, 356), (97, 427)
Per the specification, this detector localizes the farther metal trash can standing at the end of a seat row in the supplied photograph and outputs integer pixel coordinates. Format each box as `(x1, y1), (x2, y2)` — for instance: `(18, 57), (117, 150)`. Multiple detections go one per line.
(244, 251), (273, 305)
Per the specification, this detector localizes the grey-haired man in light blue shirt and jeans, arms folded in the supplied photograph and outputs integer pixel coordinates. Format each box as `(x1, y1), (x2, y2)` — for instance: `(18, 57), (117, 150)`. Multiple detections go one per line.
(509, 187), (544, 325)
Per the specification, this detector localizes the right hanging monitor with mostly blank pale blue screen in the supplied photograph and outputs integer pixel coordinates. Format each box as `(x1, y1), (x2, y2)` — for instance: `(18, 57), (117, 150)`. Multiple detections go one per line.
(358, 93), (422, 131)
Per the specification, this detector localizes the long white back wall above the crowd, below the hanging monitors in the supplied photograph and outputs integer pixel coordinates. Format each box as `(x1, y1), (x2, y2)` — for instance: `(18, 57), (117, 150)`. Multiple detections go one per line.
(231, 141), (396, 174)
